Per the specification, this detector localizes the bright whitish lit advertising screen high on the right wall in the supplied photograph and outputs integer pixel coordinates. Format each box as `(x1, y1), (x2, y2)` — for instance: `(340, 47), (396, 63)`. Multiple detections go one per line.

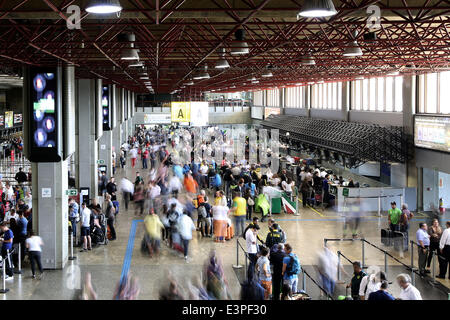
(414, 115), (450, 152)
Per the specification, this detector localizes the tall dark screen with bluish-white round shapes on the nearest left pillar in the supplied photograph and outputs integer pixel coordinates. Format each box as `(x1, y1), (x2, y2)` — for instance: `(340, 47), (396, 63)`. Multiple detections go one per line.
(30, 68), (58, 148)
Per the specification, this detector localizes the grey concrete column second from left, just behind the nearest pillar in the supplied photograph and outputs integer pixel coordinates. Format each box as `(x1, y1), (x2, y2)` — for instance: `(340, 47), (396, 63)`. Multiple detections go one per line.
(77, 79), (98, 199)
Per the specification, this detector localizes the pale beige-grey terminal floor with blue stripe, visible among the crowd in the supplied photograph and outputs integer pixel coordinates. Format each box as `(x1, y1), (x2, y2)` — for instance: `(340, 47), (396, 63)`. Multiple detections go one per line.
(0, 164), (450, 300)
